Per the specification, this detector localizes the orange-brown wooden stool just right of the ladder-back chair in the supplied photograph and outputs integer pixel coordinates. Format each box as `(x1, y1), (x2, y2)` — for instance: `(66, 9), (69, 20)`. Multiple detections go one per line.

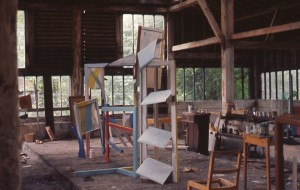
(243, 134), (272, 190)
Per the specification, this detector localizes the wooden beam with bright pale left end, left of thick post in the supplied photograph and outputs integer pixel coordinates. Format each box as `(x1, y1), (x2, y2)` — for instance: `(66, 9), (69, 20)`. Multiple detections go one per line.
(172, 37), (220, 51)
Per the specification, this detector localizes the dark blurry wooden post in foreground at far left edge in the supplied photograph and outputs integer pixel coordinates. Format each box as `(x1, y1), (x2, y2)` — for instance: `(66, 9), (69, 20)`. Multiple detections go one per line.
(0, 0), (21, 189)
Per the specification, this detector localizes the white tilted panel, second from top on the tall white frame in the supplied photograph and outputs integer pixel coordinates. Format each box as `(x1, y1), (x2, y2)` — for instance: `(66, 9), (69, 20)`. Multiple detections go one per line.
(141, 90), (171, 105)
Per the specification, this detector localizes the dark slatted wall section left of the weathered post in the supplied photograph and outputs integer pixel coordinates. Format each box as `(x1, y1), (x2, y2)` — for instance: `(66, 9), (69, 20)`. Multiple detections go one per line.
(29, 10), (73, 74)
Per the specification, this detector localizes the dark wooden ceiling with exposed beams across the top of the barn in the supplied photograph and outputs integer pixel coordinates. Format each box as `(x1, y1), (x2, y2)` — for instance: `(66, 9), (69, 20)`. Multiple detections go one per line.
(19, 0), (300, 71)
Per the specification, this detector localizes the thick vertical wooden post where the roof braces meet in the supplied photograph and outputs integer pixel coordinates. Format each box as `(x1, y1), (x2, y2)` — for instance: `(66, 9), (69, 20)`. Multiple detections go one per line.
(221, 0), (234, 114)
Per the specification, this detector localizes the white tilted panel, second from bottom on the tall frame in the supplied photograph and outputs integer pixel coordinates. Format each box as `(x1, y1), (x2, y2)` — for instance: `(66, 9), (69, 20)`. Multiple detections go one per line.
(138, 127), (172, 148)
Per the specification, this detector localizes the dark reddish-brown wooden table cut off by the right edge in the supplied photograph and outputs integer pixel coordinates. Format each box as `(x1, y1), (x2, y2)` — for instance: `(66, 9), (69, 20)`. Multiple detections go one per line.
(275, 114), (300, 190)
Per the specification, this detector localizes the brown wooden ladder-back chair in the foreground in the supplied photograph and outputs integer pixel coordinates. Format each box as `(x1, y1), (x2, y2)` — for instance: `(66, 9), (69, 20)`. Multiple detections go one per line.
(187, 149), (242, 190)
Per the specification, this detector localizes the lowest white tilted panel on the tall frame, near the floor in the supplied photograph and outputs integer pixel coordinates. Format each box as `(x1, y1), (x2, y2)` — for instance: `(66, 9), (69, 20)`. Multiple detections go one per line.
(136, 158), (173, 185)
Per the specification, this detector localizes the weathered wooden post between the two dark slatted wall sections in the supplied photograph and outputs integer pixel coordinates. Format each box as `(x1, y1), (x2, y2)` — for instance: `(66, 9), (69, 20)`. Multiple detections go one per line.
(71, 8), (82, 96)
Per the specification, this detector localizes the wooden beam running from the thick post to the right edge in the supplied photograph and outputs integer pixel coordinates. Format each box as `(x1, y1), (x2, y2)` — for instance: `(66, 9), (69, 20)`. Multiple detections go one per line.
(231, 21), (300, 40)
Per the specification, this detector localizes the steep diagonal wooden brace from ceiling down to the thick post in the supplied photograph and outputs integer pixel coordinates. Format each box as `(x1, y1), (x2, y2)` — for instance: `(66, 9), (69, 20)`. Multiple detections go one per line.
(198, 0), (223, 43)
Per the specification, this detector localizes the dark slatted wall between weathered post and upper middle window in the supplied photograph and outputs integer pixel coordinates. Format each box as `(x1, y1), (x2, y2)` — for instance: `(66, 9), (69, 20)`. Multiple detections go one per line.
(81, 11), (120, 64)
